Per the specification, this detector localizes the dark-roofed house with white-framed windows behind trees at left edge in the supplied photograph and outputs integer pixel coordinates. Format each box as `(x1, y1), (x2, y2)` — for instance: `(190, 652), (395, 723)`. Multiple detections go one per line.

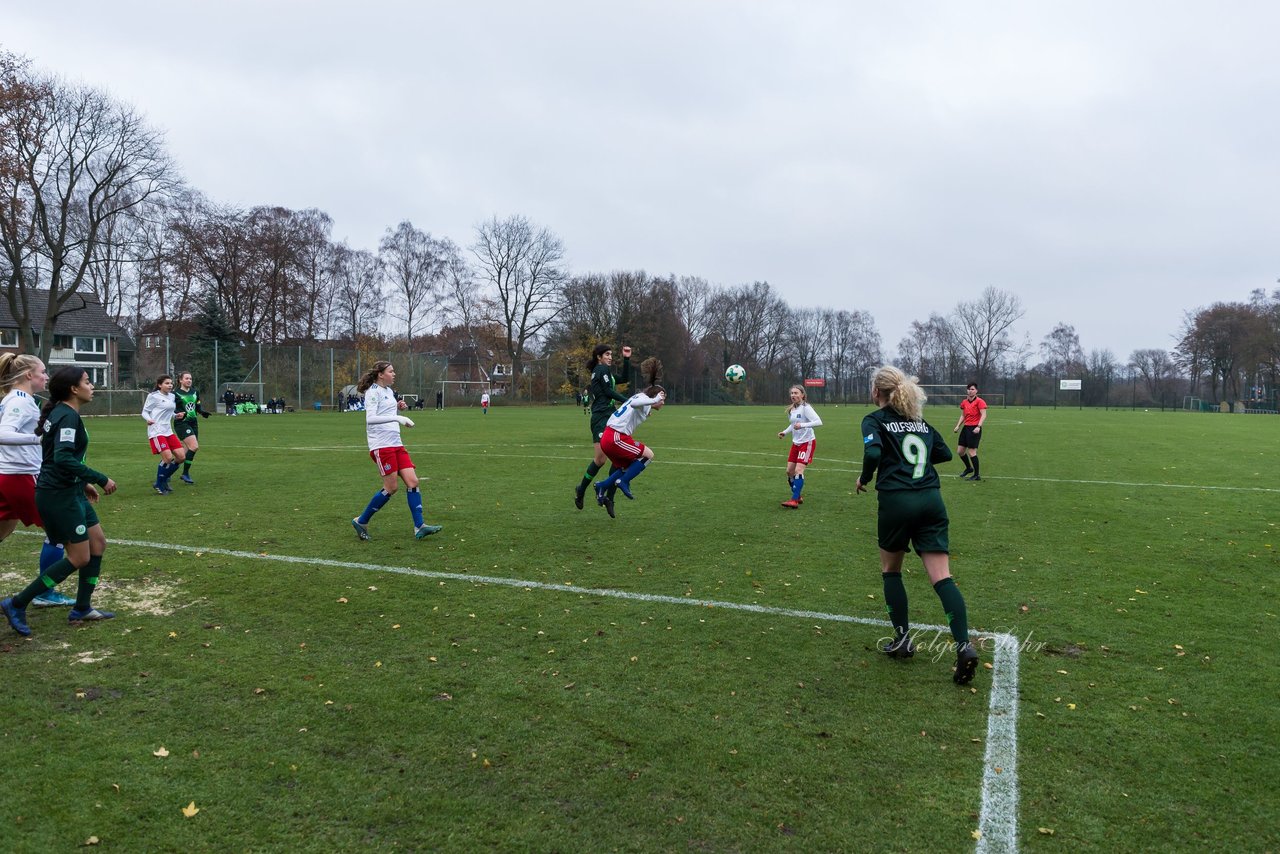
(0, 288), (134, 388)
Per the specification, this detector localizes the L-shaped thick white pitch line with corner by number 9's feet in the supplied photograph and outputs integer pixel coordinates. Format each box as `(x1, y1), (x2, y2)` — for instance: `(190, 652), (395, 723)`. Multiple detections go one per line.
(17, 531), (1019, 854)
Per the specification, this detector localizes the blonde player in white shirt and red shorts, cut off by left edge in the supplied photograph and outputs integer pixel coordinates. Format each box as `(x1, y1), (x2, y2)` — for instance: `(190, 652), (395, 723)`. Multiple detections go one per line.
(0, 353), (76, 607)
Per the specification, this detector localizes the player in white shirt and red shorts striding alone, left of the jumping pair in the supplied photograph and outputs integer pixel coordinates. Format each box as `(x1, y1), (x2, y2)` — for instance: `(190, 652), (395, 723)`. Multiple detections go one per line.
(351, 361), (442, 540)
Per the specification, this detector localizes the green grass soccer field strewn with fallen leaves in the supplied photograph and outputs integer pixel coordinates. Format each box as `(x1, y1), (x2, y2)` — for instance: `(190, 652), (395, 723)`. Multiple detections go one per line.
(0, 405), (1280, 851)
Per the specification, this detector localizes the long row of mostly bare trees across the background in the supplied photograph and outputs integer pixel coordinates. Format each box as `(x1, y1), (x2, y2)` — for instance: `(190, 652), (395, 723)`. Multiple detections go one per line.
(0, 51), (1280, 408)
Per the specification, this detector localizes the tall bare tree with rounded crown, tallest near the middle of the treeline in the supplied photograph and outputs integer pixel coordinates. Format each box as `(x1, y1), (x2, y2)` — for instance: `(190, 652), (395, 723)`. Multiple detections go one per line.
(471, 215), (567, 394)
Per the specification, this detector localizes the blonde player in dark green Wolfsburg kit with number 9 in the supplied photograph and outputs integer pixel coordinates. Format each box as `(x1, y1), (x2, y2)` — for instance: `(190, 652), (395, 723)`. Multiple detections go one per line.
(856, 366), (978, 685)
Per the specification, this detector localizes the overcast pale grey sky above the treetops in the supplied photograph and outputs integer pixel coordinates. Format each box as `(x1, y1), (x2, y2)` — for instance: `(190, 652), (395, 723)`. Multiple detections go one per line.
(0, 0), (1280, 361)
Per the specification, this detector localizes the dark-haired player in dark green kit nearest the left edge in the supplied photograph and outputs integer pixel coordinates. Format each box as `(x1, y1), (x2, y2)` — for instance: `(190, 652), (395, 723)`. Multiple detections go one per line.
(0, 367), (115, 636)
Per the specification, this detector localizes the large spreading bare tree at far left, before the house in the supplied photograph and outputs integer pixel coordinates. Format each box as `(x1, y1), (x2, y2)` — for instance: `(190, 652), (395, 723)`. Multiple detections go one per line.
(0, 61), (175, 357)
